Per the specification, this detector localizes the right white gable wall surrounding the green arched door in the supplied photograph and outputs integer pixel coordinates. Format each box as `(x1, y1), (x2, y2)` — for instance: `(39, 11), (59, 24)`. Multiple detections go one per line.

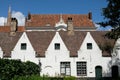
(78, 32), (110, 77)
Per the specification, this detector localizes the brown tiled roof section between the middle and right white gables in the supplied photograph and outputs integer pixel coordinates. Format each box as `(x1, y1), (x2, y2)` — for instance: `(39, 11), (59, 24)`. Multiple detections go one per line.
(60, 31), (86, 57)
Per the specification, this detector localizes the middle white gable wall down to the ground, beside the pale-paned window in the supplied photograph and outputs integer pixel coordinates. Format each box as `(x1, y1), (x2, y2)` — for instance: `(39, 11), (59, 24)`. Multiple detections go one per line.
(41, 32), (70, 76)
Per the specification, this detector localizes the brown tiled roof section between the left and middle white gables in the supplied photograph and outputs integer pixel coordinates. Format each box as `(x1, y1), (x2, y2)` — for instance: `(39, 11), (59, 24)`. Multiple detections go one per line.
(27, 31), (55, 57)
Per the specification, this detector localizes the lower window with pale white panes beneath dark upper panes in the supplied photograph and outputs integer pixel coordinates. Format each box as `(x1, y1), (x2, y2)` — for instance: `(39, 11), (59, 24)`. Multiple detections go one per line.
(60, 62), (71, 76)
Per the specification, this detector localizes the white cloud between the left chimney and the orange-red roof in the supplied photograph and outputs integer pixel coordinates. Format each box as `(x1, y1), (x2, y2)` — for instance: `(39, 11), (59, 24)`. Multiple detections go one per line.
(12, 11), (25, 26)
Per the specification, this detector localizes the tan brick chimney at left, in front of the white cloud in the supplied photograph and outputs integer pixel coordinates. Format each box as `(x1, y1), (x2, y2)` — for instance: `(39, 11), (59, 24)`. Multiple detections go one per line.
(10, 18), (18, 36)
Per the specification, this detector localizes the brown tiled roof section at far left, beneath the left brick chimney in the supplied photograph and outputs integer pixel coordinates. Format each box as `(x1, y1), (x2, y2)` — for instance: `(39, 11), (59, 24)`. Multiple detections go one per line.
(0, 32), (22, 57)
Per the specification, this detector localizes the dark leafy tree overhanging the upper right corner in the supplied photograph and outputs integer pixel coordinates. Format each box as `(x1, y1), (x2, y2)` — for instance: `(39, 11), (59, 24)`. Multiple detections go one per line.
(99, 0), (120, 39)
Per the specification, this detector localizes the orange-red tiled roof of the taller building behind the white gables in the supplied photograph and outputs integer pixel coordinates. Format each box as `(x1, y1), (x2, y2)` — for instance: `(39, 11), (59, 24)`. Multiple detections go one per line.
(25, 14), (95, 27)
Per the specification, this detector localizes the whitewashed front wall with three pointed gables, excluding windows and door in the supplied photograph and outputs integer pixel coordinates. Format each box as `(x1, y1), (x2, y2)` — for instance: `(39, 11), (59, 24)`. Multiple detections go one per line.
(8, 32), (114, 77)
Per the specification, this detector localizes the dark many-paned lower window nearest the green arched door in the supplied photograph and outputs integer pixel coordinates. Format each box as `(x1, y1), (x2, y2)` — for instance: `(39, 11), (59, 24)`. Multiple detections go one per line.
(77, 62), (87, 76)
